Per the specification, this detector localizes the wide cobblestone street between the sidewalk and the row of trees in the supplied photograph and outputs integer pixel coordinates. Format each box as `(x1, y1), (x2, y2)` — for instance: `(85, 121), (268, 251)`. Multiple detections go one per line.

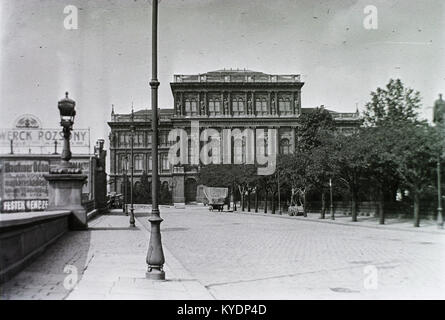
(141, 207), (445, 299)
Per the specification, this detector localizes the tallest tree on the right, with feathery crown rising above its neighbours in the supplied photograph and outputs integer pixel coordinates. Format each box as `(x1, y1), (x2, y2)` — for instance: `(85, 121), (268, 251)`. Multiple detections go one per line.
(362, 79), (426, 224)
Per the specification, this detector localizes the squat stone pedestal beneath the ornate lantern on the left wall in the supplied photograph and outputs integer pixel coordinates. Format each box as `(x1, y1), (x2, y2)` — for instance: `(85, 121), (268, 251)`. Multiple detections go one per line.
(44, 173), (88, 230)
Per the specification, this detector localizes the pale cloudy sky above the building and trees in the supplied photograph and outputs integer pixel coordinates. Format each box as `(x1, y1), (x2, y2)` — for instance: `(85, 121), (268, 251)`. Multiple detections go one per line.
(0, 0), (445, 154)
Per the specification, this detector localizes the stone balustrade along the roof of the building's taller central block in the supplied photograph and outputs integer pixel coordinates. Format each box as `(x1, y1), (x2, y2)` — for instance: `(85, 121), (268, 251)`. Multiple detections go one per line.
(174, 74), (301, 83)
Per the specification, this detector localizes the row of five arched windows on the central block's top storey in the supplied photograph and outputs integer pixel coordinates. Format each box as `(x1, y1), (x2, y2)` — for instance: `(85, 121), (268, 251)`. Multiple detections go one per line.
(180, 98), (293, 116)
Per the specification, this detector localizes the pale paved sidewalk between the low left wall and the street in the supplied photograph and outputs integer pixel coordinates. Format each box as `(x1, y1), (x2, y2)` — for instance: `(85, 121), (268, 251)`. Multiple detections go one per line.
(0, 211), (213, 300)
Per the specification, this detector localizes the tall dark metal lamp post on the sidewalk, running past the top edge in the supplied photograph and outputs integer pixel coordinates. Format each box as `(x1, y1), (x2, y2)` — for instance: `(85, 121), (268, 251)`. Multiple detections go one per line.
(146, 0), (165, 280)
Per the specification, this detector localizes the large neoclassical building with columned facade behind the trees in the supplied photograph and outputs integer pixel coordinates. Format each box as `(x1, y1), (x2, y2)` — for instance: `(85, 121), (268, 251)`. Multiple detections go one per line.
(108, 69), (360, 203)
